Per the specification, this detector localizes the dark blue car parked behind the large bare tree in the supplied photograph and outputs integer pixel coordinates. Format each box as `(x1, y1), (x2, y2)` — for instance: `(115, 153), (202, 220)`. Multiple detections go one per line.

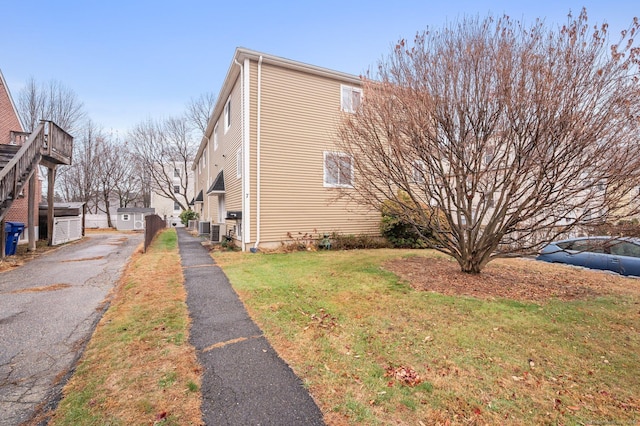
(537, 237), (640, 276)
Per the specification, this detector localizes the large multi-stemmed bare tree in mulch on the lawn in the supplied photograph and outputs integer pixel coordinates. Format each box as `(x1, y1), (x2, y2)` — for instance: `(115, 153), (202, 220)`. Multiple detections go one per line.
(340, 10), (640, 273)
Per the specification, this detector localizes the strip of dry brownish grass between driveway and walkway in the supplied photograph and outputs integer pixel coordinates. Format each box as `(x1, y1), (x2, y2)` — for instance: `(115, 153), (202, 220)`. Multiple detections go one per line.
(51, 230), (202, 425)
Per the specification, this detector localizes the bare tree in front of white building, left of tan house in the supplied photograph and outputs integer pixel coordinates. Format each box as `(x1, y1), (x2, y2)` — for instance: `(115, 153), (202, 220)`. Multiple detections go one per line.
(129, 117), (198, 210)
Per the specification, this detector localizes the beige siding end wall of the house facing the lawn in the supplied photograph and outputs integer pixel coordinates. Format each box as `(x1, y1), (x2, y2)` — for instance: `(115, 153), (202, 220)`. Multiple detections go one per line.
(252, 60), (379, 243)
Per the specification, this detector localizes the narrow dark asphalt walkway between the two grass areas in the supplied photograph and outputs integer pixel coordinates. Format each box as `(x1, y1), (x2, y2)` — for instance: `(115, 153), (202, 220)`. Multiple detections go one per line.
(178, 228), (324, 426)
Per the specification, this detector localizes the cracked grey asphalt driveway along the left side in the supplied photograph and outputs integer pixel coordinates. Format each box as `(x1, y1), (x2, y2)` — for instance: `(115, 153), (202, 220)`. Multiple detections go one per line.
(0, 232), (143, 426)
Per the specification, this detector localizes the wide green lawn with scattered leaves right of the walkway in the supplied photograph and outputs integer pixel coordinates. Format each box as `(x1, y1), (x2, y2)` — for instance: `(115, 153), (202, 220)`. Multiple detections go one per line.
(214, 250), (640, 425)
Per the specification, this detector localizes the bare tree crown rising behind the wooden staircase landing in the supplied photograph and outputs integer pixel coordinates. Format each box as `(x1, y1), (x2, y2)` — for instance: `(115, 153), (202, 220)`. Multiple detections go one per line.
(17, 77), (86, 134)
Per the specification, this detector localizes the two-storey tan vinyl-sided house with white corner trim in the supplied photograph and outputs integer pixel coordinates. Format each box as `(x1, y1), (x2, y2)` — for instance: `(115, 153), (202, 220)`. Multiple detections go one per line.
(194, 48), (380, 250)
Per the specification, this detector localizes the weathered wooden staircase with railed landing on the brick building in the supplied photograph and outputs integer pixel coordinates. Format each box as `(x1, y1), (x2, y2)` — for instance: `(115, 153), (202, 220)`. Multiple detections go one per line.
(0, 121), (73, 221)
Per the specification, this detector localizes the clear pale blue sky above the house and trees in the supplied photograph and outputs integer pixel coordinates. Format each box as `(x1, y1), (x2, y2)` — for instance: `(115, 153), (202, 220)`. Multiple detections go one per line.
(0, 0), (640, 135)
